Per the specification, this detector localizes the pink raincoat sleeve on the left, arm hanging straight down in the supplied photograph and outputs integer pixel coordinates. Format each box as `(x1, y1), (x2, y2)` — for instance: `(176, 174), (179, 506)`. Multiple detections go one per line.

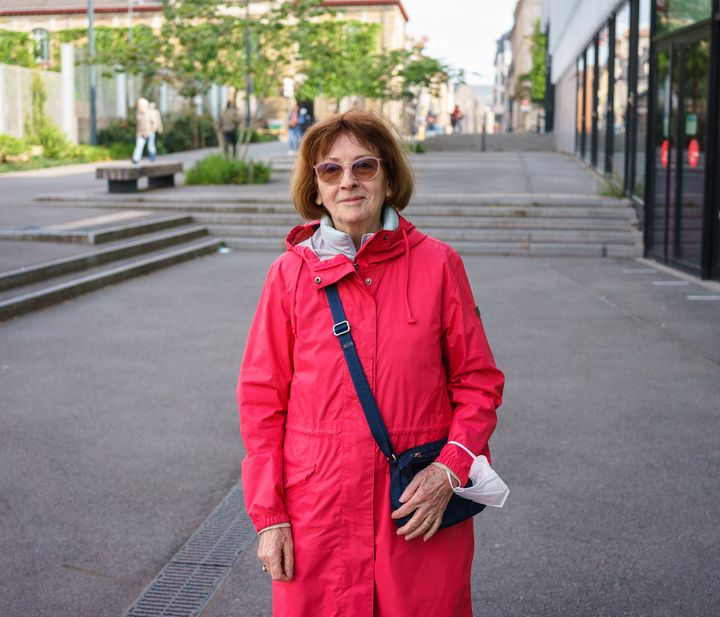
(237, 262), (295, 531)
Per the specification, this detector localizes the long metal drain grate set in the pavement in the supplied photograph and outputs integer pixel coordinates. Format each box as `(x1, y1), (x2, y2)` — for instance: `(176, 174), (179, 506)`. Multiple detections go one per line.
(124, 484), (255, 617)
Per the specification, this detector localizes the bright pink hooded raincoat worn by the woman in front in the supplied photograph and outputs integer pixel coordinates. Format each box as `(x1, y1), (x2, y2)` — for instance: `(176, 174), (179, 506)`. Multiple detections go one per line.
(238, 218), (503, 617)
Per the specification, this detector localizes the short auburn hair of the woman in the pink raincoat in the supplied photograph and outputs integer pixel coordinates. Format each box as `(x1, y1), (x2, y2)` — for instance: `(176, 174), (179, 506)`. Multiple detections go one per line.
(290, 109), (415, 220)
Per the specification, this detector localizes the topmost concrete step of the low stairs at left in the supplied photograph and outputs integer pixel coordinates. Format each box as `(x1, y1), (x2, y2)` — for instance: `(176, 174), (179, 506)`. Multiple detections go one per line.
(0, 214), (192, 244)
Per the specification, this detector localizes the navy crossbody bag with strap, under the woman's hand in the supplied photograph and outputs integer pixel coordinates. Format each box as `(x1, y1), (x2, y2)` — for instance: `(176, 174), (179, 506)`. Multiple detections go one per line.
(325, 284), (485, 529)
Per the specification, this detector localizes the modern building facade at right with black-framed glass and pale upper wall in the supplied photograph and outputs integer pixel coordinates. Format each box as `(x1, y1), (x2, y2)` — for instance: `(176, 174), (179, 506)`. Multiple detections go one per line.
(543, 0), (720, 280)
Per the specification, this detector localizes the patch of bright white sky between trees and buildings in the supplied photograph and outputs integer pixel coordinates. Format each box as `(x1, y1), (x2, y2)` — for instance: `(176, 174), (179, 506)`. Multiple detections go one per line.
(402, 0), (515, 85)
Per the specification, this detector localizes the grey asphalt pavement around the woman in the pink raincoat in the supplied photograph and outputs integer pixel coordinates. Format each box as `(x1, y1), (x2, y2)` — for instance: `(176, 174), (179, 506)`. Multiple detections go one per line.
(0, 144), (720, 617)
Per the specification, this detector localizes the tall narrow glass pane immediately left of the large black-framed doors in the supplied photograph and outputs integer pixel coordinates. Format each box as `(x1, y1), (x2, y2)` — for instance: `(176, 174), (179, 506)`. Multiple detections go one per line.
(633, 0), (652, 199)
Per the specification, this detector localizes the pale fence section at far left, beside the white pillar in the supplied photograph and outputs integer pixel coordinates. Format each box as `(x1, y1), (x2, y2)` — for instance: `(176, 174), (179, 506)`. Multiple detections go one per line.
(0, 64), (63, 137)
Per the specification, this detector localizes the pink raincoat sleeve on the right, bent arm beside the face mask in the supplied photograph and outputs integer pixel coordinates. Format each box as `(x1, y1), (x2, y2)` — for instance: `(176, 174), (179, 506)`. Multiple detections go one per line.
(436, 251), (505, 485)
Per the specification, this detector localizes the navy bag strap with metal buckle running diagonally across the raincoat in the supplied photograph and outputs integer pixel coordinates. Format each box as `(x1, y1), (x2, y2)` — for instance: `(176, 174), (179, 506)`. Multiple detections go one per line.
(325, 283), (397, 461)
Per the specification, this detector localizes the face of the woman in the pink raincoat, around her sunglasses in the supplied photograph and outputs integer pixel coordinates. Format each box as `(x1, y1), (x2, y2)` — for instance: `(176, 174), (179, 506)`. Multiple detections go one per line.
(315, 133), (389, 240)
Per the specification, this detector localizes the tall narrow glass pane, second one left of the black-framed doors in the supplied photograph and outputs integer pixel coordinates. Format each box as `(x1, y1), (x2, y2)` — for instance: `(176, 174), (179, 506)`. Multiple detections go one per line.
(611, 3), (630, 185)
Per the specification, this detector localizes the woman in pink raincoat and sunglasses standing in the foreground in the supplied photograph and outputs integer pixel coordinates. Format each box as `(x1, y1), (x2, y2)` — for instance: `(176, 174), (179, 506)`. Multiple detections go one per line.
(238, 110), (503, 617)
